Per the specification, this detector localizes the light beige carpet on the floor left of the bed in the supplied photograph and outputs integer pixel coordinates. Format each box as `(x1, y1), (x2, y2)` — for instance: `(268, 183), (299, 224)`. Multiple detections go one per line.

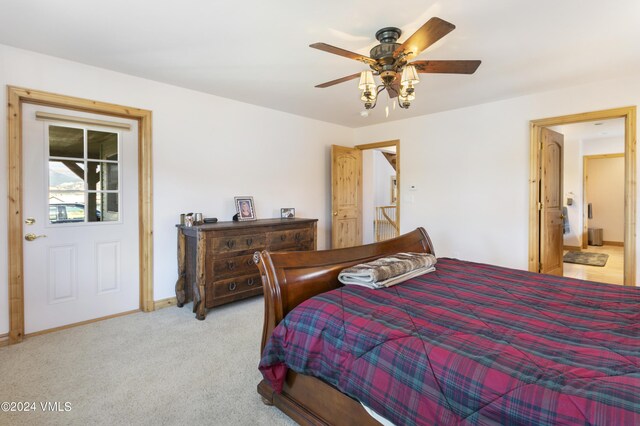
(0, 297), (294, 426)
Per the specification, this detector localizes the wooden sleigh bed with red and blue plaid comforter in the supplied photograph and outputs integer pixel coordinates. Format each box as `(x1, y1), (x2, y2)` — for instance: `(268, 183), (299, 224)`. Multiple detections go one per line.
(255, 228), (640, 425)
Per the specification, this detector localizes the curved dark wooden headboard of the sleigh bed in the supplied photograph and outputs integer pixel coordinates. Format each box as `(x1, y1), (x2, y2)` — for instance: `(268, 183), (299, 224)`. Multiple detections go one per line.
(254, 228), (435, 350)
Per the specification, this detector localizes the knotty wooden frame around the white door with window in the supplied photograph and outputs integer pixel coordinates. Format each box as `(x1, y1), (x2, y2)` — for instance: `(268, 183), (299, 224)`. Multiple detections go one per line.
(7, 86), (154, 344)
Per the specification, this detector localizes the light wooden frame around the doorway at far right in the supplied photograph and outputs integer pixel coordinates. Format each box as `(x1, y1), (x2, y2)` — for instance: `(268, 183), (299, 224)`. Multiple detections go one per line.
(529, 106), (636, 286)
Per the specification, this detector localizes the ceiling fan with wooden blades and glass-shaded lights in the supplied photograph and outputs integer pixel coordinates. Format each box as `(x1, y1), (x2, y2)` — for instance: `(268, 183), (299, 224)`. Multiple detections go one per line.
(309, 17), (481, 109)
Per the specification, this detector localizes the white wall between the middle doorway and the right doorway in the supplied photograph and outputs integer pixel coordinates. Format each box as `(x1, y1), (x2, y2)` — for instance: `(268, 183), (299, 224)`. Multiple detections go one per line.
(356, 78), (640, 282)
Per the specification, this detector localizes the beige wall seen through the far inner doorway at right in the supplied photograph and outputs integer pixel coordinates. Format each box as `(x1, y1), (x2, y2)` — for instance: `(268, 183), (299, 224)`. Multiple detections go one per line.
(587, 157), (624, 243)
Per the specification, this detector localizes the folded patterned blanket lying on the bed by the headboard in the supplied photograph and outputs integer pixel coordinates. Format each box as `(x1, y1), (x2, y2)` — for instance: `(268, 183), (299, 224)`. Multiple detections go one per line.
(338, 253), (437, 288)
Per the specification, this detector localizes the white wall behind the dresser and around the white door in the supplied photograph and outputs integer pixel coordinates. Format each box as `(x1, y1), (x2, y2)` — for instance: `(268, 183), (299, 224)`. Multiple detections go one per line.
(0, 45), (354, 334)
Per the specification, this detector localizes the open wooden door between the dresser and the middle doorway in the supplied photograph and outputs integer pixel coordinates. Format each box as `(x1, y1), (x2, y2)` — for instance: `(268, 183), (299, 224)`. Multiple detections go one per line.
(331, 145), (362, 248)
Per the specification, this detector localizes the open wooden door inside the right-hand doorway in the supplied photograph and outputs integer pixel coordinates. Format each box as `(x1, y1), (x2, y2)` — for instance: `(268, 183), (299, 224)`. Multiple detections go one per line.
(540, 128), (564, 276)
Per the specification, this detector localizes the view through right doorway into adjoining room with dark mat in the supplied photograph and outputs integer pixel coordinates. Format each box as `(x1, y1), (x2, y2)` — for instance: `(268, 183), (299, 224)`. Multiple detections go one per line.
(551, 118), (625, 284)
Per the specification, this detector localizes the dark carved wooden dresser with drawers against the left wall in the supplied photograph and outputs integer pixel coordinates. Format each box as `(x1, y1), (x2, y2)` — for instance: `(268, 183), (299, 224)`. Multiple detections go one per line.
(176, 218), (318, 320)
